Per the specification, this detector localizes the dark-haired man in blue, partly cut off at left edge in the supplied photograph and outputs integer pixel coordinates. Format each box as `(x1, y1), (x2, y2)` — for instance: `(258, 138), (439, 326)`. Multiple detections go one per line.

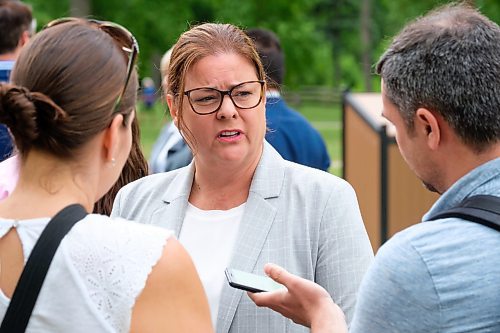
(0, 0), (35, 161)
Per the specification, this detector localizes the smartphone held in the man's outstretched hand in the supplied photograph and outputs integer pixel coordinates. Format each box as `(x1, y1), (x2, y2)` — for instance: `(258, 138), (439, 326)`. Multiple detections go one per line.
(225, 268), (285, 293)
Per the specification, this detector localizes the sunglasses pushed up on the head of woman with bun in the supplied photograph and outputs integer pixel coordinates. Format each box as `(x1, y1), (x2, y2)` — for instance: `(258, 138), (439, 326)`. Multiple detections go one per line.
(42, 17), (139, 113)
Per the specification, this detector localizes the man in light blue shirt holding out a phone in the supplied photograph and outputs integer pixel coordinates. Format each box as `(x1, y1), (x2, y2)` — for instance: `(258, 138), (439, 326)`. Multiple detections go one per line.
(251, 4), (500, 333)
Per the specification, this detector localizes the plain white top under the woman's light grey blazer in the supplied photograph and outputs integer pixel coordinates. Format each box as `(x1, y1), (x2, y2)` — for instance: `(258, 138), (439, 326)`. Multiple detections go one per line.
(179, 203), (245, 325)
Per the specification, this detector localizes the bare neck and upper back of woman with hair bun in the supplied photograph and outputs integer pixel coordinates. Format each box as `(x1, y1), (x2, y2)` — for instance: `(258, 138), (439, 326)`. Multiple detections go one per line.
(0, 151), (95, 219)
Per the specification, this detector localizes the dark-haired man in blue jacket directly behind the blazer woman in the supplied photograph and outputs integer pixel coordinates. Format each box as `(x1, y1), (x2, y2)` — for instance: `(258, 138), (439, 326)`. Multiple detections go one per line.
(246, 29), (330, 171)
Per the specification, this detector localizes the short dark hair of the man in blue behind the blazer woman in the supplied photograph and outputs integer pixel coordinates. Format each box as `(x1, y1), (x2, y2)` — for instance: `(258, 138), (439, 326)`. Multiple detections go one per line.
(246, 28), (285, 88)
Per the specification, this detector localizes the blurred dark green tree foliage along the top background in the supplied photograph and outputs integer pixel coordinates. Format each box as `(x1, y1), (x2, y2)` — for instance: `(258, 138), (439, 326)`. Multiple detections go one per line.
(26, 0), (500, 91)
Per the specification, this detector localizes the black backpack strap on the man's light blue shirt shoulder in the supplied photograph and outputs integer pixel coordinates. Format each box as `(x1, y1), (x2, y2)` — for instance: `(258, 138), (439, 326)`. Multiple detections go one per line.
(428, 195), (500, 231)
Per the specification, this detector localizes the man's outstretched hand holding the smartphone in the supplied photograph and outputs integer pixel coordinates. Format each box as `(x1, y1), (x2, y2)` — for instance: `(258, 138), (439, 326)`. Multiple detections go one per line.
(248, 264), (347, 333)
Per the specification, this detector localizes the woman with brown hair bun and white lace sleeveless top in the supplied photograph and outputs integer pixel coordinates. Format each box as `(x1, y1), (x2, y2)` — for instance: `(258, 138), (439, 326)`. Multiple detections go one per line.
(0, 19), (211, 332)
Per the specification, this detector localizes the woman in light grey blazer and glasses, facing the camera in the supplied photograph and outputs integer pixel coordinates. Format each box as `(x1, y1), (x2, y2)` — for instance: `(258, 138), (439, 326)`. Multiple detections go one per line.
(112, 24), (373, 333)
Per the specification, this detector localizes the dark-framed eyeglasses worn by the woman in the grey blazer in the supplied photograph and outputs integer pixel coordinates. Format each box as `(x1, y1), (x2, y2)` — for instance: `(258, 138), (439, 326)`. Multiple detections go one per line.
(184, 80), (264, 115)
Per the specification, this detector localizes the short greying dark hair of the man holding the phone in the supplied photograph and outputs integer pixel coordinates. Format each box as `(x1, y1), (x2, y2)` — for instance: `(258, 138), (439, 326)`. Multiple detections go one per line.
(377, 4), (500, 152)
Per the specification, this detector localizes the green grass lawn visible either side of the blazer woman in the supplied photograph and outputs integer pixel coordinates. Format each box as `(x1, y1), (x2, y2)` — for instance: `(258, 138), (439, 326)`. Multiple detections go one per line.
(137, 102), (342, 176)
